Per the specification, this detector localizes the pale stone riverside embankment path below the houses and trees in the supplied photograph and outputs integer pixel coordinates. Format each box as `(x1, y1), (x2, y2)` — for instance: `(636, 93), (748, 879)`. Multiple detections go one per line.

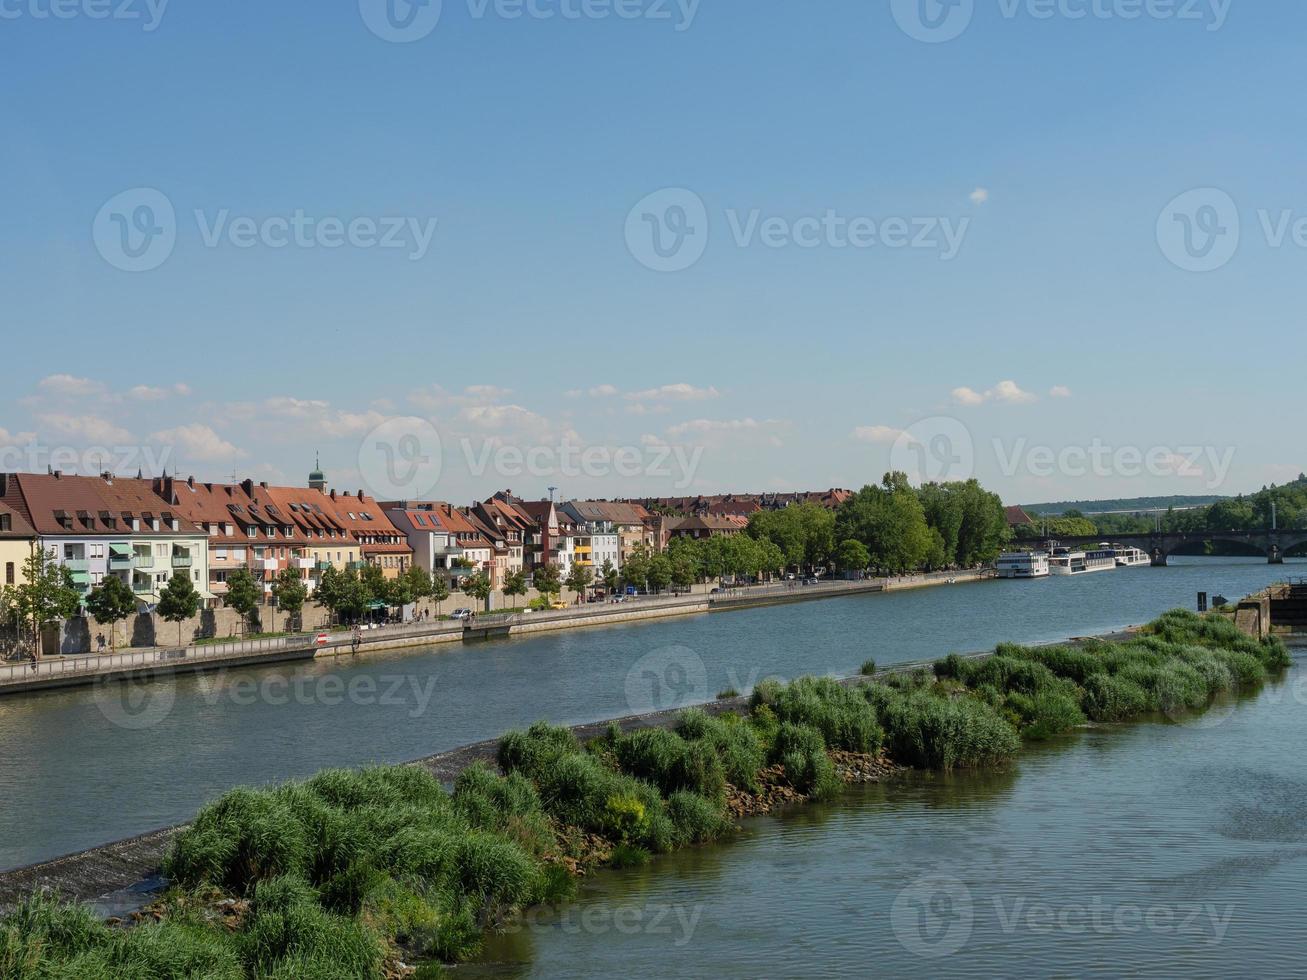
(0, 570), (991, 696)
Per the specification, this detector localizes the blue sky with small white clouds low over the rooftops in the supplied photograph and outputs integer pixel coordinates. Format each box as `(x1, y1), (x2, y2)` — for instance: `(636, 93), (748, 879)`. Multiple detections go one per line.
(0, 0), (1307, 502)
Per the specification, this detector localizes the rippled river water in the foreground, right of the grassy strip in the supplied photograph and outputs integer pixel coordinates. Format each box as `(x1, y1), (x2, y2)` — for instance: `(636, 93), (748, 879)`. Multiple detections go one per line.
(475, 660), (1307, 980)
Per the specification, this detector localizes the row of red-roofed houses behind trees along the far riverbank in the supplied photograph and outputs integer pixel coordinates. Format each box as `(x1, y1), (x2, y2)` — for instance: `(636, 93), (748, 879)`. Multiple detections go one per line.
(0, 468), (843, 606)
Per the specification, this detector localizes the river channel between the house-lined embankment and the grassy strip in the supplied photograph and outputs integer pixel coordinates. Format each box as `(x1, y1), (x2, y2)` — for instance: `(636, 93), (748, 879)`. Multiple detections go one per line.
(0, 558), (1294, 868)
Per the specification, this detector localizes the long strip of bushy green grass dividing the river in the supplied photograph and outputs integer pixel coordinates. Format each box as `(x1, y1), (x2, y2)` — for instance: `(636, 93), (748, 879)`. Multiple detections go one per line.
(0, 613), (1289, 980)
